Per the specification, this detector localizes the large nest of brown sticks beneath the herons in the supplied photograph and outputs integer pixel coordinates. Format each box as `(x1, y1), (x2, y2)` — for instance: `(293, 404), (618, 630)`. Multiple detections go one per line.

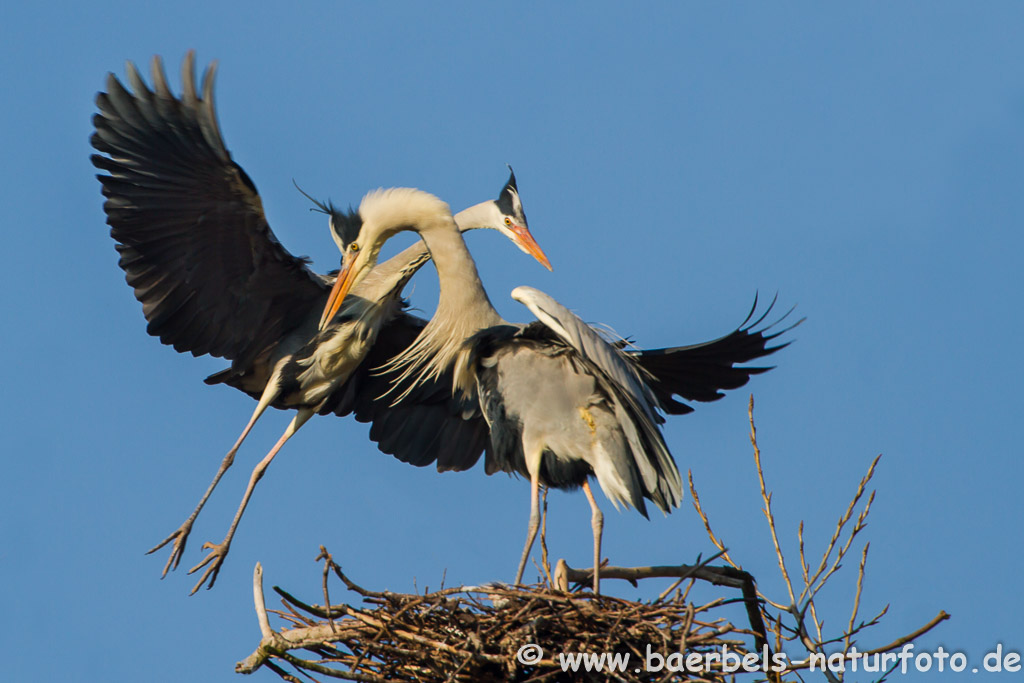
(237, 559), (751, 683)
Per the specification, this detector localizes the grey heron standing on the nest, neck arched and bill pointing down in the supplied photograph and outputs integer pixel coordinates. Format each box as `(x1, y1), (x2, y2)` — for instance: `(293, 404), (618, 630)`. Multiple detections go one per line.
(324, 188), (798, 592)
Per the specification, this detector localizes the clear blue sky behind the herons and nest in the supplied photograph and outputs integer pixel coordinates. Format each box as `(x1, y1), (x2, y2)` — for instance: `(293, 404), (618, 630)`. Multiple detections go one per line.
(0, 1), (1024, 681)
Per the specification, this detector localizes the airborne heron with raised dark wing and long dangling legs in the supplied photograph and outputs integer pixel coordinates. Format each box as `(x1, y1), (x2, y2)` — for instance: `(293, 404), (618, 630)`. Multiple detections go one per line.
(91, 52), (551, 593)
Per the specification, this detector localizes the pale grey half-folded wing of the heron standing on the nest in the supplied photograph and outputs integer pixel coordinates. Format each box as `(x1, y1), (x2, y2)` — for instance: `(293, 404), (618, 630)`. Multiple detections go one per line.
(512, 287), (683, 511)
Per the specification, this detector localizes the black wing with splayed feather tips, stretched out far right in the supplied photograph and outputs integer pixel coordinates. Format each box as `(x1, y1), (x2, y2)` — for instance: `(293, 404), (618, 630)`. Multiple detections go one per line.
(626, 296), (804, 415)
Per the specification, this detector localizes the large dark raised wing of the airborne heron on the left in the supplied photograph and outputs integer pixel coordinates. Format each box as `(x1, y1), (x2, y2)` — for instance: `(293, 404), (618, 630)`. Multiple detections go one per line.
(91, 52), (326, 366)
